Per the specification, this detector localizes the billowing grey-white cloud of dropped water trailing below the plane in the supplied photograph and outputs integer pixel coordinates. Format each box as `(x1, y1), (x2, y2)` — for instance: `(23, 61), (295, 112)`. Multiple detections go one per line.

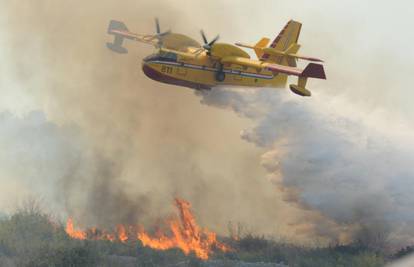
(201, 89), (414, 249)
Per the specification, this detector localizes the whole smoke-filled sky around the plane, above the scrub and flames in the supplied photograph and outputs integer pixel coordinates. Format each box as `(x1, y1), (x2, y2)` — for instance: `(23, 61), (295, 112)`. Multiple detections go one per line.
(0, 0), (414, 247)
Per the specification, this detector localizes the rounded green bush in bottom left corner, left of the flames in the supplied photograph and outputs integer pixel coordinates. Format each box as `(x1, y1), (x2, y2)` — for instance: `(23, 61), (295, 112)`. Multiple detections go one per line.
(0, 204), (99, 267)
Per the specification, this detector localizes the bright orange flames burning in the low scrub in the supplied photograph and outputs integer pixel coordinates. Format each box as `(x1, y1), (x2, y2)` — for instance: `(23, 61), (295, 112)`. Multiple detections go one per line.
(65, 198), (231, 260)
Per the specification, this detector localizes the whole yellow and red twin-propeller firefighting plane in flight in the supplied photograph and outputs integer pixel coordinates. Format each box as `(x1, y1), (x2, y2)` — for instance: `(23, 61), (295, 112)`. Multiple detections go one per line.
(107, 19), (326, 96)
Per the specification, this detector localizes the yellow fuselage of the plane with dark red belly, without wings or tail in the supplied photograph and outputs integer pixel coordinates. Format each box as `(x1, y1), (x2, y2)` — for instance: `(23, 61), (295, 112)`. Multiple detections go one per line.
(142, 53), (287, 89)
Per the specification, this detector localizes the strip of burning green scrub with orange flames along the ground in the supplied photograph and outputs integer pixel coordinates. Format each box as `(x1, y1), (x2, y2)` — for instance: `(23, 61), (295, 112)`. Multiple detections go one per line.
(0, 199), (400, 267)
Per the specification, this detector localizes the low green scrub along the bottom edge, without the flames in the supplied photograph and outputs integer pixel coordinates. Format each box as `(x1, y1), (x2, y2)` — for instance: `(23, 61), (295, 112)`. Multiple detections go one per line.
(0, 206), (392, 267)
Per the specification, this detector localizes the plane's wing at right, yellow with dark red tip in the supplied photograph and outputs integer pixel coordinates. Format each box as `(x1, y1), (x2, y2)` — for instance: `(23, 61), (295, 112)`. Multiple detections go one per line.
(221, 57), (326, 79)
